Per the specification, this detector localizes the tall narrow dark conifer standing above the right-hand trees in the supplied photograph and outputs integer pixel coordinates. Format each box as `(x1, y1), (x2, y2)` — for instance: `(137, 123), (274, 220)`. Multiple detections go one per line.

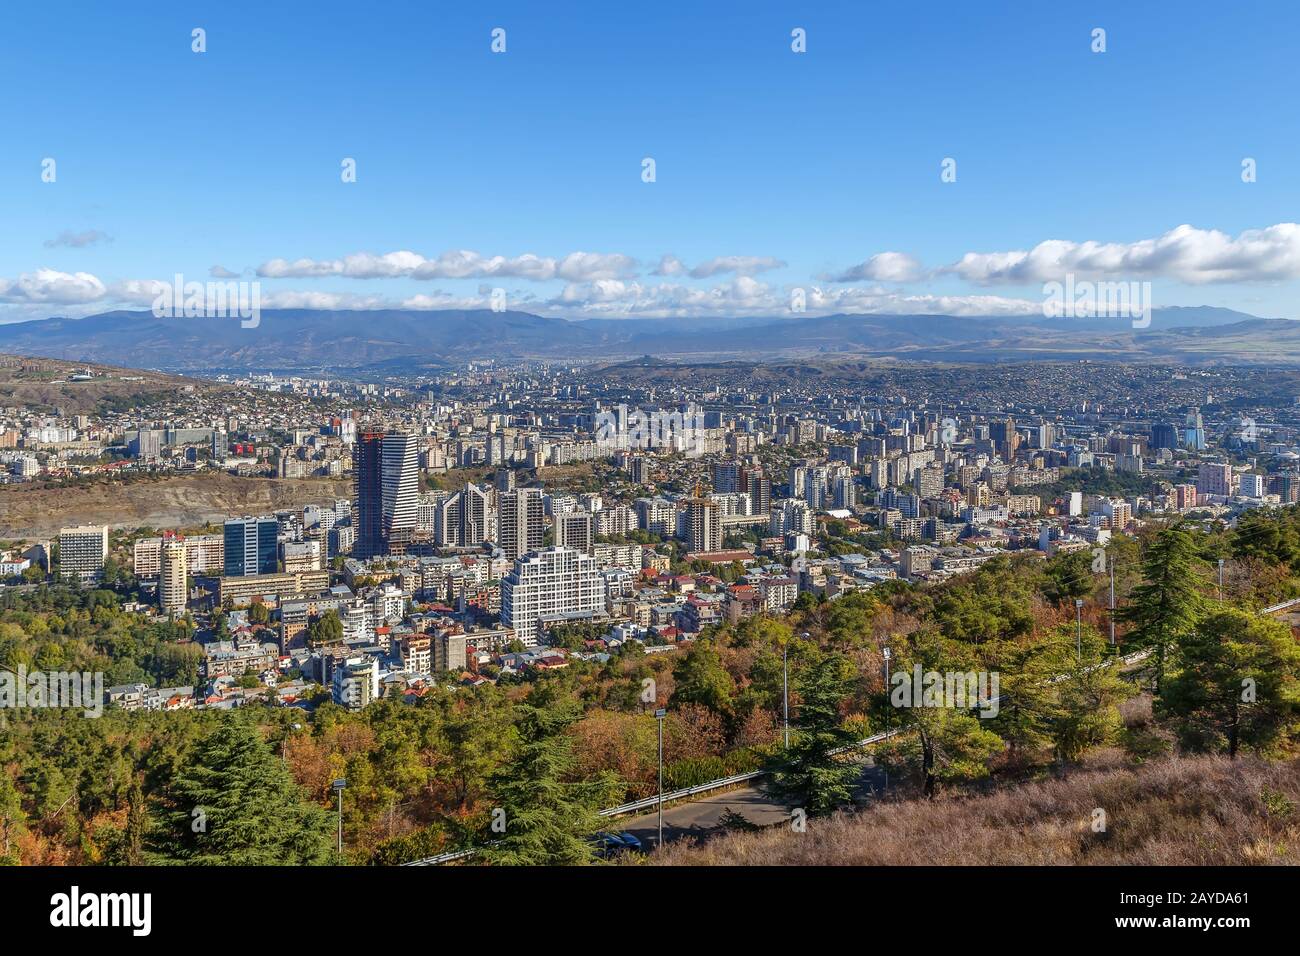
(1119, 528), (1205, 693)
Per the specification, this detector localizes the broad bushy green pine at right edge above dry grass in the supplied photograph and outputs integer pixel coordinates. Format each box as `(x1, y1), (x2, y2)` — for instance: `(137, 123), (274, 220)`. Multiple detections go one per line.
(1156, 607), (1300, 758)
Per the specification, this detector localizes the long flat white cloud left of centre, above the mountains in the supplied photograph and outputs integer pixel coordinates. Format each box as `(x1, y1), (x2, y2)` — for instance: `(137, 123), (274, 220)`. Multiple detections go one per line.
(257, 250), (636, 282)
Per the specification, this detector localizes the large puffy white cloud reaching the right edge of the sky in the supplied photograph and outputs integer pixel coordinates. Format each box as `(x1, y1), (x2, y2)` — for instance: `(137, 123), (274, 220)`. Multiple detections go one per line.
(945, 222), (1300, 285)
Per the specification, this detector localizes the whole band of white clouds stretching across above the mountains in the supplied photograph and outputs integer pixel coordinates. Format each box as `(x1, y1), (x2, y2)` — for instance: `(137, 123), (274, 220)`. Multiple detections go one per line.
(10, 222), (1300, 321)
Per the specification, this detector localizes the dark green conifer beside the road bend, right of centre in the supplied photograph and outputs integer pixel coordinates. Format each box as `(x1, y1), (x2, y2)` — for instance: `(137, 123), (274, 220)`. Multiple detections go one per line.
(771, 654), (862, 817)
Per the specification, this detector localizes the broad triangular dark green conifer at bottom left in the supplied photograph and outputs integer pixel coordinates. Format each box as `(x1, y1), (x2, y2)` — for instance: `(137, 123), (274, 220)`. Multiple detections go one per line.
(153, 717), (334, 866)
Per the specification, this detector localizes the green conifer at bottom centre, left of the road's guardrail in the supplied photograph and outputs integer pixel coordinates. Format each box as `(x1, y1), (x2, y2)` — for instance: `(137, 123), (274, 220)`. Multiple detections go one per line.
(481, 704), (611, 866)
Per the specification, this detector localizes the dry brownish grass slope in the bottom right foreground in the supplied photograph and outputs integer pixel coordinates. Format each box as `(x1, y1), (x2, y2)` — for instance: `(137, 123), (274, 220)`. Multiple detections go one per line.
(650, 753), (1300, 866)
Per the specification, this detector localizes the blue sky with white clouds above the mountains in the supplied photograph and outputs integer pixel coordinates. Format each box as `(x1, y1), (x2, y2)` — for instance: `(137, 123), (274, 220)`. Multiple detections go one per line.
(0, 0), (1300, 321)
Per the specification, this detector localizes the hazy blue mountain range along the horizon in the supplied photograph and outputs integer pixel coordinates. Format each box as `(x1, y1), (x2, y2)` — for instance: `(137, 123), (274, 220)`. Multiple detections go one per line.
(0, 306), (1300, 372)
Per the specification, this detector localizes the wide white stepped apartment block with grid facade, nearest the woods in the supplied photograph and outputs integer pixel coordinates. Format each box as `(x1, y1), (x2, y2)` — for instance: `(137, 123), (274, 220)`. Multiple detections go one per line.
(501, 548), (605, 648)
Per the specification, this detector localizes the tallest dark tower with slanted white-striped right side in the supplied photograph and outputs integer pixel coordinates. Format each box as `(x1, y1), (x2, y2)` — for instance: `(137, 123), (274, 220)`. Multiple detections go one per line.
(352, 432), (420, 558)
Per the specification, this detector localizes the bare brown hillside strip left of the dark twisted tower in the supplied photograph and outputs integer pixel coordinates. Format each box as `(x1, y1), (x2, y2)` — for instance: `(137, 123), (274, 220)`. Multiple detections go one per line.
(0, 472), (348, 538)
